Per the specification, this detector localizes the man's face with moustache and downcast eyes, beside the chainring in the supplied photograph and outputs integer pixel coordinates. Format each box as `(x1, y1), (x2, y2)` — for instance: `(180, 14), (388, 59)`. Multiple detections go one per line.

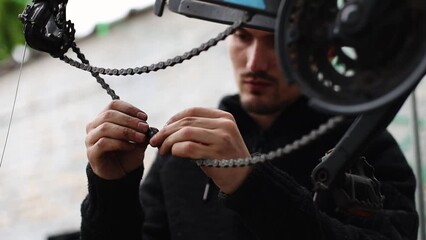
(229, 29), (300, 115)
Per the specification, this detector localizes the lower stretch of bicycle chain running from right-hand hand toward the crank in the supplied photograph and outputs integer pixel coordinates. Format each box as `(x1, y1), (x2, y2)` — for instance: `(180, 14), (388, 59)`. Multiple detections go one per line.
(195, 116), (344, 168)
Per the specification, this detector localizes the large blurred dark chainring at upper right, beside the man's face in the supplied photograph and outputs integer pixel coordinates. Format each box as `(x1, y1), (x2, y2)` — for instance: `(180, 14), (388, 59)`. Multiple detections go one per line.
(275, 0), (426, 114)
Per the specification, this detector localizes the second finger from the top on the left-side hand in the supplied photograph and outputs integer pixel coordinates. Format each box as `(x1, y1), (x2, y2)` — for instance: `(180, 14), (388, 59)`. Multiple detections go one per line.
(86, 110), (149, 133)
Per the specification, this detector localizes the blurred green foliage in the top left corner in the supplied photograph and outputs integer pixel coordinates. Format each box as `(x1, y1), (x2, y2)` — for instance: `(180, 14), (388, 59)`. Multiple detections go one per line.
(0, 0), (28, 61)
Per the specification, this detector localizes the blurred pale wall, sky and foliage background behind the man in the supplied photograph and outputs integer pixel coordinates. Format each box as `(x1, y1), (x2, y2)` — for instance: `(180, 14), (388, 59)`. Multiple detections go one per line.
(0, 0), (426, 240)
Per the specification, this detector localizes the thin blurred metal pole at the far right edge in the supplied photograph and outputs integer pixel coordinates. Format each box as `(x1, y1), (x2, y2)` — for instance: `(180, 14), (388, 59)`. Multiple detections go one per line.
(411, 91), (426, 240)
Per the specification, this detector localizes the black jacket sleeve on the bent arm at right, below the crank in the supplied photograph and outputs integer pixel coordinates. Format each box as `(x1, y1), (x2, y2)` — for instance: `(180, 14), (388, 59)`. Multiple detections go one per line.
(224, 133), (418, 240)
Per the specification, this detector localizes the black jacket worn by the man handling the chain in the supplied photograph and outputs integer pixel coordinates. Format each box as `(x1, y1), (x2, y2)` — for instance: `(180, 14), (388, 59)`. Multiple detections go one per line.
(82, 96), (418, 240)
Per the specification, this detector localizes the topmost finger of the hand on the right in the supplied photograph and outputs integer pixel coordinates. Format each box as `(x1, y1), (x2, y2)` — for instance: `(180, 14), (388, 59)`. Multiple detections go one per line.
(167, 107), (234, 125)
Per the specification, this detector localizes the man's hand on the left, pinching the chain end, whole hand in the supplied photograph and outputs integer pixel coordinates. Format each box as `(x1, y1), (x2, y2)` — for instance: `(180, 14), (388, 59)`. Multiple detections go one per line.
(86, 100), (149, 180)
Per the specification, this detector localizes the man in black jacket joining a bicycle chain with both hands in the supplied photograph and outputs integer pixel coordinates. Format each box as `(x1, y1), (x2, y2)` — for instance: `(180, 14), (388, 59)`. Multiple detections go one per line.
(81, 29), (418, 240)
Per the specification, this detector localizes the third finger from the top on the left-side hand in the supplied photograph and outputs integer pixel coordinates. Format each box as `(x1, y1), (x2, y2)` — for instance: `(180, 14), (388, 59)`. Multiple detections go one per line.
(86, 122), (148, 146)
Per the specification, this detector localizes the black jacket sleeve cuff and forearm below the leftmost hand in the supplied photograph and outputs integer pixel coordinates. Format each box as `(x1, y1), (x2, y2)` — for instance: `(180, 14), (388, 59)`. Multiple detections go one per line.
(80, 166), (143, 240)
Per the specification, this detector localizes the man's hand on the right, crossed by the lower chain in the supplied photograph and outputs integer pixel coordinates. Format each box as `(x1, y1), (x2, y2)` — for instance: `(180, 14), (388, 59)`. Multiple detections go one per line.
(150, 108), (251, 194)
